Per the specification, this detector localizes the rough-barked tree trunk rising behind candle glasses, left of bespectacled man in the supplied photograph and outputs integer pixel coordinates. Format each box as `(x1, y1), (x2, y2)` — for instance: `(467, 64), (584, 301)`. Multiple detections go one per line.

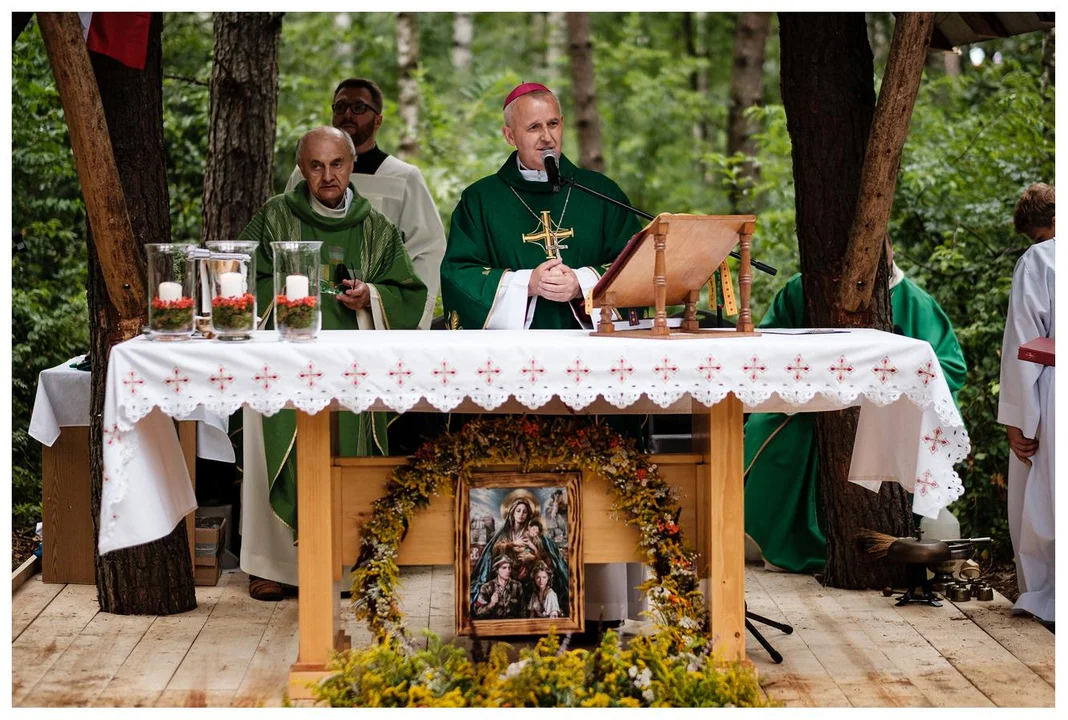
(201, 13), (283, 242)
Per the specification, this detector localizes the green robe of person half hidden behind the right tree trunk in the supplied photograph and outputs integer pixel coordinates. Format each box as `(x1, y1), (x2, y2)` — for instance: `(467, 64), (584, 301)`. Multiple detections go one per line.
(744, 275), (967, 573)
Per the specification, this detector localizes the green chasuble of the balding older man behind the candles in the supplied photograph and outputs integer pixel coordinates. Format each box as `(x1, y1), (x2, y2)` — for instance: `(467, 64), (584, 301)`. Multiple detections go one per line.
(240, 182), (426, 531)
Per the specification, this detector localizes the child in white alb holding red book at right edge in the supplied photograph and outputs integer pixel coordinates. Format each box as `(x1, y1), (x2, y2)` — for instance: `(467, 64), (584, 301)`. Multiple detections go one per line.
(998, 183), (1056, 623)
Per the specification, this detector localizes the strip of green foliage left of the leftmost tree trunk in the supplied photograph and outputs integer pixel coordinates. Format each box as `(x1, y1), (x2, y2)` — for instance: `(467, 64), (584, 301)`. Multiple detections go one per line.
(11, 22), (89, 527)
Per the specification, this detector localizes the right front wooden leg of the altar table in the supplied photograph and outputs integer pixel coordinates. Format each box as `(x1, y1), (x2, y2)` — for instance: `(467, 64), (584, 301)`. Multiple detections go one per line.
(693, 395), (745, 659)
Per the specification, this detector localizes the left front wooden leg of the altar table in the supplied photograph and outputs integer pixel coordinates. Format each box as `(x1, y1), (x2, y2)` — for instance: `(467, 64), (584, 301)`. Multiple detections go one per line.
(289, 410), (341, 696)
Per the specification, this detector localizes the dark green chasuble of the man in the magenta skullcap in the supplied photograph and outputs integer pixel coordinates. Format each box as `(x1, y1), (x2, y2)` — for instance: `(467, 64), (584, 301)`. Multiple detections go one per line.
(441, 153), (641, 330)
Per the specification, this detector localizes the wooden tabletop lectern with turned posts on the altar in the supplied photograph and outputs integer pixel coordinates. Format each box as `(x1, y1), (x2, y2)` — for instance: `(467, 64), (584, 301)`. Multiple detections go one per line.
(591, 213), (759, 339)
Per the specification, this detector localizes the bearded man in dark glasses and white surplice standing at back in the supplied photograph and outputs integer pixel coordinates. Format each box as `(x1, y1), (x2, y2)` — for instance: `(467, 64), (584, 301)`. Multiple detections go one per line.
(285, 78), (445, 330)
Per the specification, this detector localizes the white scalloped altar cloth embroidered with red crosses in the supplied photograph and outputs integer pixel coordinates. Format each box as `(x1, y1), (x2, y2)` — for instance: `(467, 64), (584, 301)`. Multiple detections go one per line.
(100, 330), (970, 553)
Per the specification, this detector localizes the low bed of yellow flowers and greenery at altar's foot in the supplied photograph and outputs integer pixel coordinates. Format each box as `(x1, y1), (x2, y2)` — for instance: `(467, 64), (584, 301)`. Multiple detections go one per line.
(312, 630), (780, 707)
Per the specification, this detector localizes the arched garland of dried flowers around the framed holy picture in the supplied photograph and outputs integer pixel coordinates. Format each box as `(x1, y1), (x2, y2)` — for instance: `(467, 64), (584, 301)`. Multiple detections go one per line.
(352, 417), (707, 647)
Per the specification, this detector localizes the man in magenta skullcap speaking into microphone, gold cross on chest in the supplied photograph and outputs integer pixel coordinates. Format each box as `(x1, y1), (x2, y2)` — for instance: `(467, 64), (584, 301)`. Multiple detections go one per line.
(441, 82), (641, 624)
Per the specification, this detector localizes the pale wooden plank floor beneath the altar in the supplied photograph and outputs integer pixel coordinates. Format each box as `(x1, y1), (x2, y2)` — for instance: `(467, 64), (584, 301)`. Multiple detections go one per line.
(12, 566), (1055, 707)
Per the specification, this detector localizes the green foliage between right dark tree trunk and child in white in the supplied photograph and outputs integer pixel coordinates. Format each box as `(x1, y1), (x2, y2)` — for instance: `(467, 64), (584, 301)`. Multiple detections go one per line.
(891, 44), (1054, 558)
